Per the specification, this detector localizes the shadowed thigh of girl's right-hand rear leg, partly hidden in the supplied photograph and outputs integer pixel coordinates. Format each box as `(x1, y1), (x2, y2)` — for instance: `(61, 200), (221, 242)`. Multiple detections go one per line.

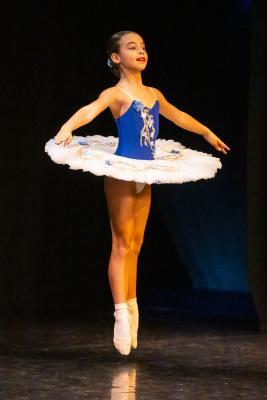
(134, 185), (151, 238)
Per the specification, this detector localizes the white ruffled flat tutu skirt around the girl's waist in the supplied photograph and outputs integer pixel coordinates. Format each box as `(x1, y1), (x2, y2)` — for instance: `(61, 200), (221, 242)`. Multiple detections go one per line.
(45, 135), (222, 191)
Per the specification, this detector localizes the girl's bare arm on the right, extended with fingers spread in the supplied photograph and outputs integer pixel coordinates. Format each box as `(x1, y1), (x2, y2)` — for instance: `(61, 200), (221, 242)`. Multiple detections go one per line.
(153, 88), (230, 154)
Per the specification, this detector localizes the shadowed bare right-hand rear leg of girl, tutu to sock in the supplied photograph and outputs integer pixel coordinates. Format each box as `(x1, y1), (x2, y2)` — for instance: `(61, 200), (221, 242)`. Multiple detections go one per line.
(126, 185), (151, 299)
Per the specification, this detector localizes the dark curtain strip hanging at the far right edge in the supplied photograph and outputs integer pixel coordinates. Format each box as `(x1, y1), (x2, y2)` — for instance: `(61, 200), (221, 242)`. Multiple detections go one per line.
(247, 0), (267, 332)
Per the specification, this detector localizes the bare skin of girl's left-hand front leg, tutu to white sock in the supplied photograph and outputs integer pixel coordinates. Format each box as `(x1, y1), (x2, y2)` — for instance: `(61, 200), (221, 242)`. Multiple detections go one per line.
(104, 177), (138, 303)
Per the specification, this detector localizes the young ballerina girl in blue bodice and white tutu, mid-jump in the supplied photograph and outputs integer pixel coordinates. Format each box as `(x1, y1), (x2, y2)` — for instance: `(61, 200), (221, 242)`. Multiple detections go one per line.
(46, 31), (230, 355)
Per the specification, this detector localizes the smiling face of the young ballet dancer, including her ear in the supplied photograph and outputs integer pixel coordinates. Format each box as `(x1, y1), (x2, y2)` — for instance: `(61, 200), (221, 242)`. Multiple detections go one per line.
(111, 33), (148, 72)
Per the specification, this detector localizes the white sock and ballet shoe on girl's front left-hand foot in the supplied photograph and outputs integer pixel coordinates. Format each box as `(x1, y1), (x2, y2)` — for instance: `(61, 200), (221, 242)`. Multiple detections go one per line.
(113, 309), (131, 355)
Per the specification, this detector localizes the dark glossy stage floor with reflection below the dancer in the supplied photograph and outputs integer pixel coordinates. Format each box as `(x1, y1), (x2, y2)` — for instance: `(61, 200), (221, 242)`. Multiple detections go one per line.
(0, 307), (267, 400)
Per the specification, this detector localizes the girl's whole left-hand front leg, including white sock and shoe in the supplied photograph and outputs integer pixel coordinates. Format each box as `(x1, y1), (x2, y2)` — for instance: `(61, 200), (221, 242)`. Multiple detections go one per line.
(104, 177), (139, 355)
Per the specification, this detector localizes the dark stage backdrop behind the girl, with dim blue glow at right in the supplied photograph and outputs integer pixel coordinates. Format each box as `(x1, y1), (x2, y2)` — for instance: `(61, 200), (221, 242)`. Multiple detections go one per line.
(0, 0), (266, 328)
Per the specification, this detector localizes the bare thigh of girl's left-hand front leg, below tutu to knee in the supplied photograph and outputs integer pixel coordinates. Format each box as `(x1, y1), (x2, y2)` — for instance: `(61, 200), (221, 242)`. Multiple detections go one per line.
(104, 176), (137, 237)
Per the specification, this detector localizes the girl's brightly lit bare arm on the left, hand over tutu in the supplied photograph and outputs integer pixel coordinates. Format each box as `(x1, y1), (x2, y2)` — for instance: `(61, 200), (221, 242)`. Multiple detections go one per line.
(55, 87), (117, 146)
